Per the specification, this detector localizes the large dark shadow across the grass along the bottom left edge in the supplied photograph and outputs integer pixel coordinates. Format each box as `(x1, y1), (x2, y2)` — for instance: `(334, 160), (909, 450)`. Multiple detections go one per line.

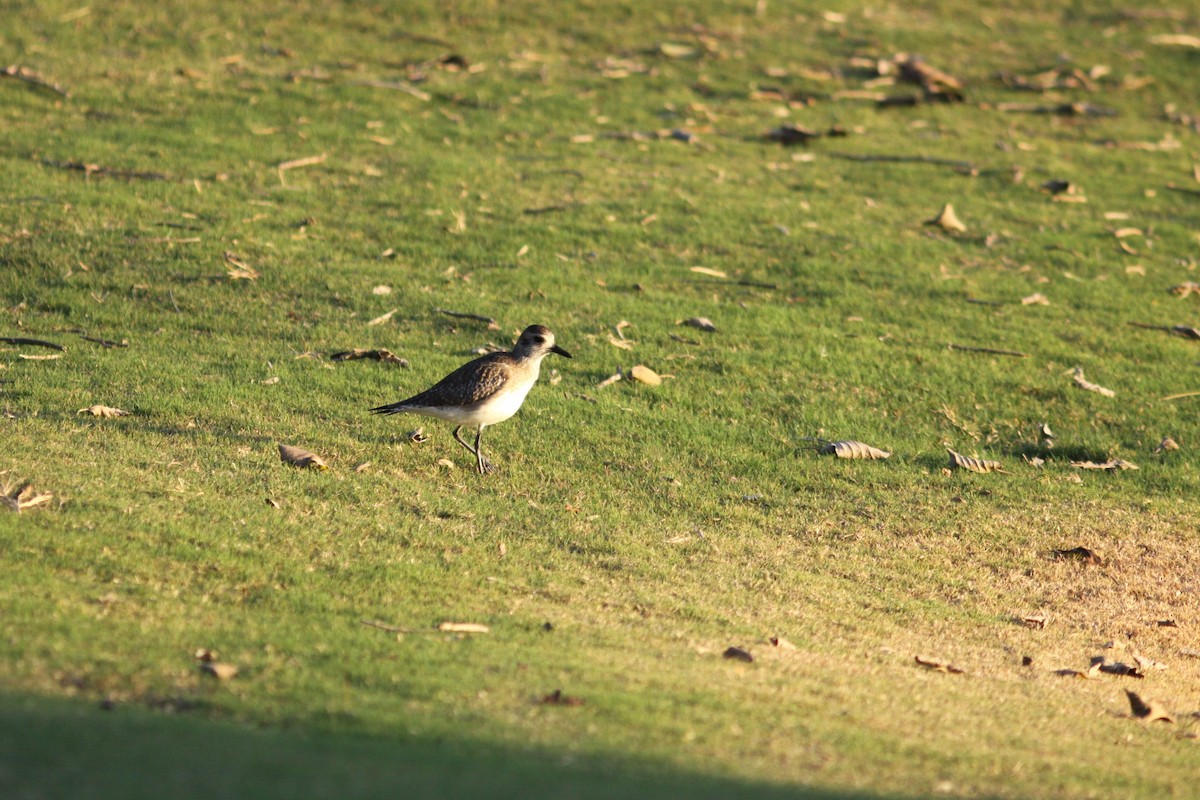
(0, 694), (872, 800)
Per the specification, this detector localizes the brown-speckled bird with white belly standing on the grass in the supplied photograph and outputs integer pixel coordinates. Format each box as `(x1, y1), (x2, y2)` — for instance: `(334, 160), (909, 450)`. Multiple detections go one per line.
(371, 325), (572, 475)
